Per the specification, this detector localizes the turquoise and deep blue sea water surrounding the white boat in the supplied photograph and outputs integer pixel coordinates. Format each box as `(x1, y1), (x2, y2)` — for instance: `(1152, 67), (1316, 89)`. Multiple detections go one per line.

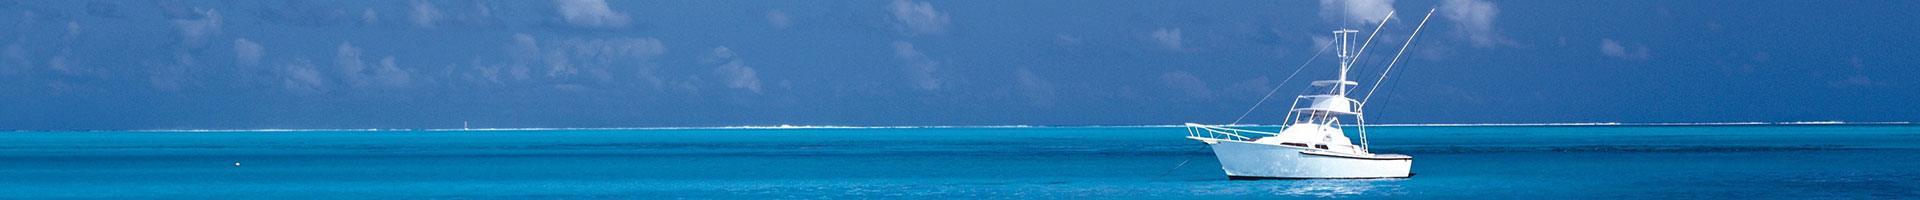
(0, 125), (1920, 198)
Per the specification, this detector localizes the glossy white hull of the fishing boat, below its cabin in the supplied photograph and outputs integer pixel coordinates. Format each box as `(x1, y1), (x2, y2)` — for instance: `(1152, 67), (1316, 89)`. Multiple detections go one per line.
(1208, 140), (1413, 179)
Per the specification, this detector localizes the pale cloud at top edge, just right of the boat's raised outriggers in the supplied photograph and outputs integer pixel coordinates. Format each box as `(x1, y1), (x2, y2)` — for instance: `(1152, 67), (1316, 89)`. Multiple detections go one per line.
(1440, 0), (1511, 48)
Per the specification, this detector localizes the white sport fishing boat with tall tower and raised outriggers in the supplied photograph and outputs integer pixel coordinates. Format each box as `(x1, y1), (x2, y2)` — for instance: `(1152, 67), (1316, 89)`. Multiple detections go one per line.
(1187, 12), (1432, 179)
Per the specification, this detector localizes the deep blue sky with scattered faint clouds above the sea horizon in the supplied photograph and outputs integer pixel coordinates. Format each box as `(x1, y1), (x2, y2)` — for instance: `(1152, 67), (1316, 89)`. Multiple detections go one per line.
(0, 0), (1920, 129)
